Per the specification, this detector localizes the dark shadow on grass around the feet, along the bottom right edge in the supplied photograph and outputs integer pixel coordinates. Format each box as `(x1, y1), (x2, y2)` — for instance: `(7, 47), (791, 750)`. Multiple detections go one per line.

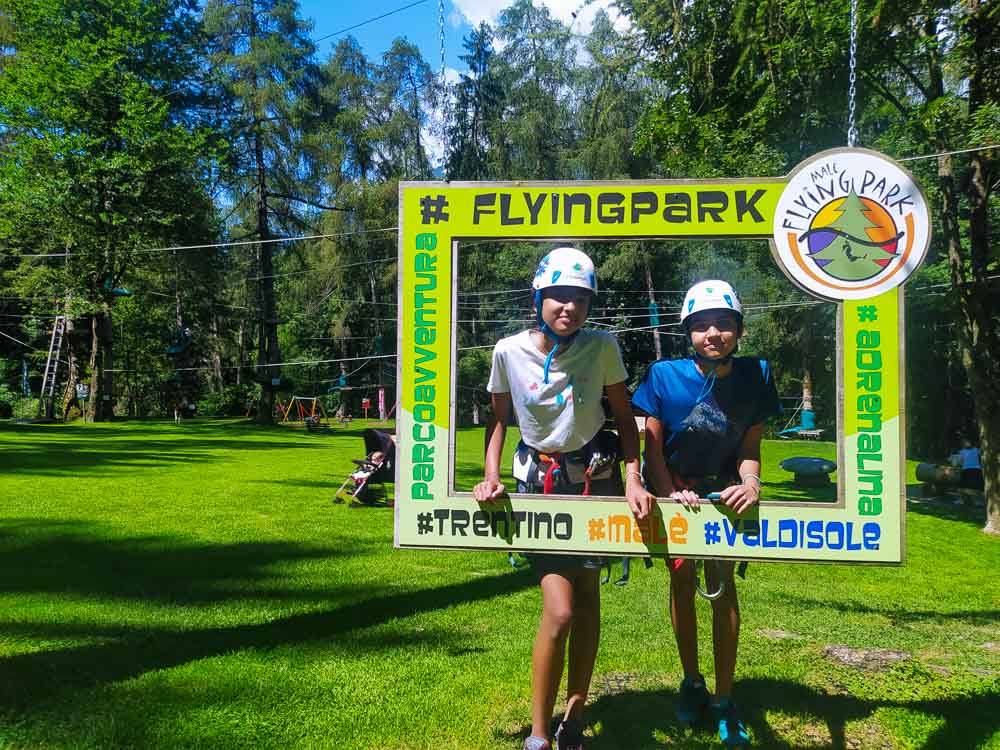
(499, 679), (1000, 750)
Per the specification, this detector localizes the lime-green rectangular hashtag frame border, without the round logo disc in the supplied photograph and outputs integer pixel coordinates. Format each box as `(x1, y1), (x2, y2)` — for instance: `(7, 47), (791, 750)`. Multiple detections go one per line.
(394, 164), (906, 564)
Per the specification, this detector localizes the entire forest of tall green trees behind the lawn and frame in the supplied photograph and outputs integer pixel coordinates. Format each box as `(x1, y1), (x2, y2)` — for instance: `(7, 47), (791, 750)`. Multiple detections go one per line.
(0, 0), (1000, 533)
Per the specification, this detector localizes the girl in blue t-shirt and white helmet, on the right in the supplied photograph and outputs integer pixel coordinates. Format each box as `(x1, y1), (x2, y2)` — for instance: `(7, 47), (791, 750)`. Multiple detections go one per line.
(632, 280), (781, 745)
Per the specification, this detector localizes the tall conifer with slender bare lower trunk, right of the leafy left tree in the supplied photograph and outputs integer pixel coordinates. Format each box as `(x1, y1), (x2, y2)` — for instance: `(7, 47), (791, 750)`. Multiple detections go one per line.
(205, 0), (330, 424)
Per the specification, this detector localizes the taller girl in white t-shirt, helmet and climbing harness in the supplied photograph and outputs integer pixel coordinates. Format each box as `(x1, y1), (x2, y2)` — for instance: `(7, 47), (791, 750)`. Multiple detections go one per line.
(475, 247), (655, 750)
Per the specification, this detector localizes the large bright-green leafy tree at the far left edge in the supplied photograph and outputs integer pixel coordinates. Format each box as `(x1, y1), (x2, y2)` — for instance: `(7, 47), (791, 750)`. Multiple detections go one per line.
(0, 0), (217, 419)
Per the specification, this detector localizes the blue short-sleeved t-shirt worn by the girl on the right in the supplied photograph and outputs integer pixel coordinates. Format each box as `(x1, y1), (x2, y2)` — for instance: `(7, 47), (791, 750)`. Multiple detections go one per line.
(632, 357), (781, 478)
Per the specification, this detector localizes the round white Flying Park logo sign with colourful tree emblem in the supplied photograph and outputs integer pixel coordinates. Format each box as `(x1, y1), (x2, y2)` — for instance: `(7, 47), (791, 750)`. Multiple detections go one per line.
(771, 148), (931, 300)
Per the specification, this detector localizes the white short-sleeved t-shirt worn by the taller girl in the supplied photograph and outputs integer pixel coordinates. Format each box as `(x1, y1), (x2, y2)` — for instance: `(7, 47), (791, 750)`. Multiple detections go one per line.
(487, 328), (628, 453)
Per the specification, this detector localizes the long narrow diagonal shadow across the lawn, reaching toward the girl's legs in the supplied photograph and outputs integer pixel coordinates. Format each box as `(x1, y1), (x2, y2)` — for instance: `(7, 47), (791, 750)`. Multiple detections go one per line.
(0, 573), (535, 714)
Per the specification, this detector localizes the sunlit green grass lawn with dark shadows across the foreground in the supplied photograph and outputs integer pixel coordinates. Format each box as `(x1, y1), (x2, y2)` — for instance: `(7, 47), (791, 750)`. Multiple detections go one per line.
(0, 421), (1000, 750)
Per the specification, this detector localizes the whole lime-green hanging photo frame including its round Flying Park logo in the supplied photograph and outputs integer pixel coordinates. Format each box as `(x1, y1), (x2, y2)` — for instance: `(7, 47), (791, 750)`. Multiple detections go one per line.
(395, 149), (930, 564)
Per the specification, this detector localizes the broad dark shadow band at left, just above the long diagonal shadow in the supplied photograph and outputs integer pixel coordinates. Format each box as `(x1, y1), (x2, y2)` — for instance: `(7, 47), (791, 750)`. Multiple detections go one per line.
(0, 519), (376, 608)
